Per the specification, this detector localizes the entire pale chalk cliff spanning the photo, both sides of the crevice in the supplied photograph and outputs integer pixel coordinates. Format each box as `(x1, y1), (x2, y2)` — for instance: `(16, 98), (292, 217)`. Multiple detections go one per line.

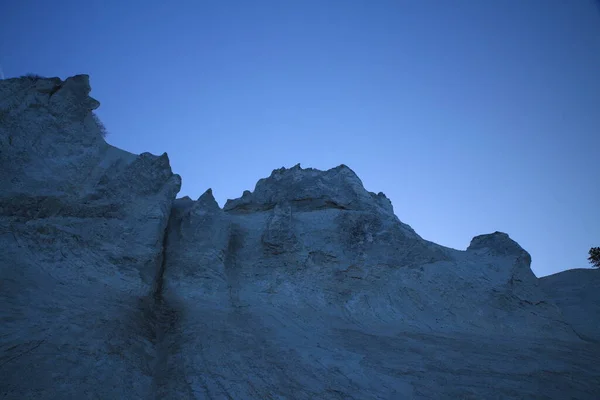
(0, 75), (600, 399)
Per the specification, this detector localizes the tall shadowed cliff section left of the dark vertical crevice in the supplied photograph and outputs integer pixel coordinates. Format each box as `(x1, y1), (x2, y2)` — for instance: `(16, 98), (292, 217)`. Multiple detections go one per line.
(0, 75), (180, 399)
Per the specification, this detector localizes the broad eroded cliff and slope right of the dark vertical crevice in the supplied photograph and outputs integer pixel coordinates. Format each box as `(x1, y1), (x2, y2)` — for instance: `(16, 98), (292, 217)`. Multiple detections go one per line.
(156, 166), (600, 399)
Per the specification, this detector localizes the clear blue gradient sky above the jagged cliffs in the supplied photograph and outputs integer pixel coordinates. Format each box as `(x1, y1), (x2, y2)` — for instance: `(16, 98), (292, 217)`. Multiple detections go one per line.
(0, 0), (600, 276)
